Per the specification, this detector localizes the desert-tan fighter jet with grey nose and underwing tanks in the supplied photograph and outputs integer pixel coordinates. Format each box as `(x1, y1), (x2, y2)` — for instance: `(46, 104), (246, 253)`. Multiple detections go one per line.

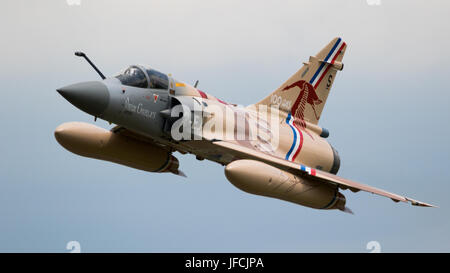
(55, 38), (434, 213)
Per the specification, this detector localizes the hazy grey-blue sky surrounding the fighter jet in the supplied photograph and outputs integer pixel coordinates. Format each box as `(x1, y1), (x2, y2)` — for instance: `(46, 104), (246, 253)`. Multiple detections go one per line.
(0, 0), (450, 252)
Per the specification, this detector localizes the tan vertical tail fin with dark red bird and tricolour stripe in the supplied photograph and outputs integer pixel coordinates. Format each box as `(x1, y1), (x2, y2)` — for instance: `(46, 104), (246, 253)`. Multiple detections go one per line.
(256, 38), (347, 124)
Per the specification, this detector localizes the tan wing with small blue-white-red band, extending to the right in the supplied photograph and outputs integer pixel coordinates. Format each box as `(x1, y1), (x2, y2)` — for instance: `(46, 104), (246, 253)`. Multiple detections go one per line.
(213, 141), (436, 207)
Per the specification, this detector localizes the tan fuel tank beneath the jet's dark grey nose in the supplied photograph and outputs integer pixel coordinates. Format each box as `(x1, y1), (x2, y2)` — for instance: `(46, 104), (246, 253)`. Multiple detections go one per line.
(55, 122), (182, 175)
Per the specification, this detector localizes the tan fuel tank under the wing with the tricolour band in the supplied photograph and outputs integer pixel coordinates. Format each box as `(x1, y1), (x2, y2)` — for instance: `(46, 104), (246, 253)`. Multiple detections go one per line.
(225, 159), (348, 211)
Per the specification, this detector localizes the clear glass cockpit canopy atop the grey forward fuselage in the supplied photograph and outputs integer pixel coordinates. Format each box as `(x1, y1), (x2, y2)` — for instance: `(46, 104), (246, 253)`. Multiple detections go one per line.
(116, 65), (169, 90)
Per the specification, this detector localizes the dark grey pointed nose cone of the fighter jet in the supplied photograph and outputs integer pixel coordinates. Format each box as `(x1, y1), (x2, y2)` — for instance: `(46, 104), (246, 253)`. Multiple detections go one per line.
(56, 81), (109, 116)
